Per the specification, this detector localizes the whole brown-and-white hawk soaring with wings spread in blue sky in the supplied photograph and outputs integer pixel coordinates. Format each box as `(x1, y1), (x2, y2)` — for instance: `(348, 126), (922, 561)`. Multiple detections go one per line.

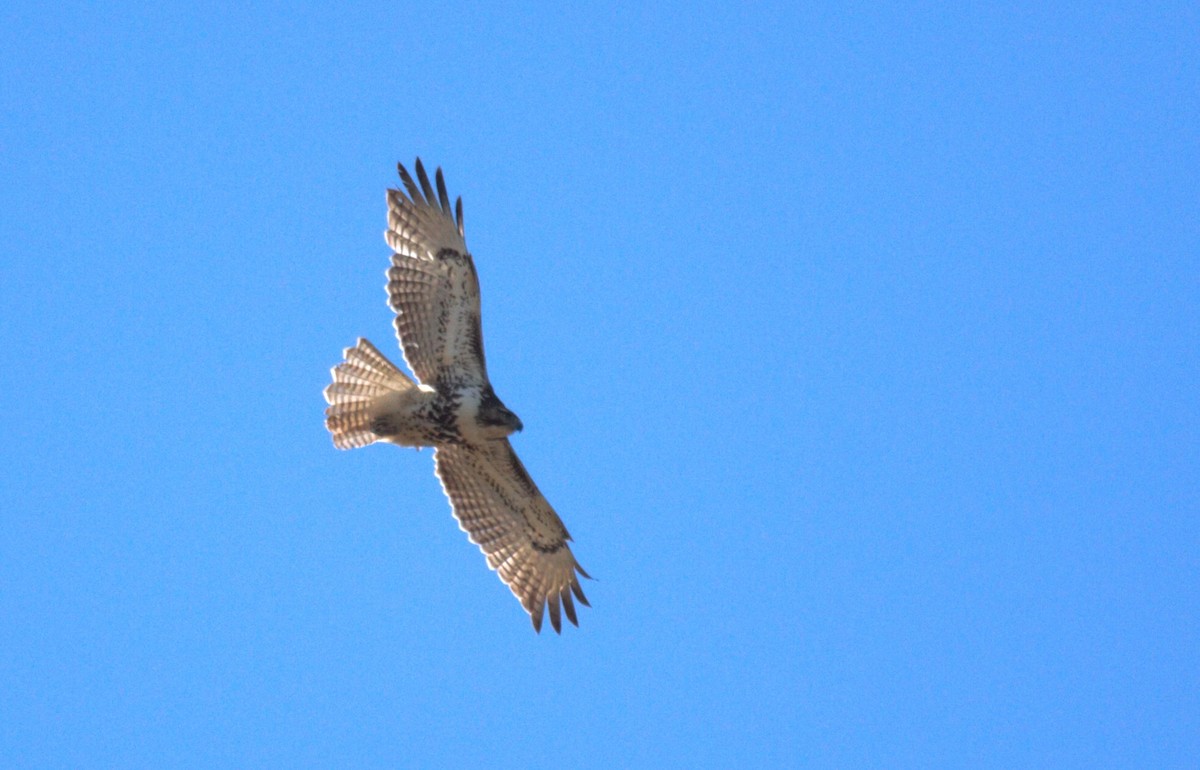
(325, 158), (590, 633)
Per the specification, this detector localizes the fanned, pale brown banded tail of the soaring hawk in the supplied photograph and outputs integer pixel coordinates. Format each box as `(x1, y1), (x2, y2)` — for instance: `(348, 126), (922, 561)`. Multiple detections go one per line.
(325, 337), (416, 449)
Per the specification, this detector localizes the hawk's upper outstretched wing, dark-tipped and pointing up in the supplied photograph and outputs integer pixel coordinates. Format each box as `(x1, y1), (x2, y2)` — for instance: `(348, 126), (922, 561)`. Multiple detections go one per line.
(384, 158), (487, 387)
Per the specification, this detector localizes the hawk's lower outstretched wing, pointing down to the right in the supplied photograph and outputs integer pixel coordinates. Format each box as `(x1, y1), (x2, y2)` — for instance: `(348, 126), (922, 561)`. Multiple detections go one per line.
(434, 439), (589, 632)
